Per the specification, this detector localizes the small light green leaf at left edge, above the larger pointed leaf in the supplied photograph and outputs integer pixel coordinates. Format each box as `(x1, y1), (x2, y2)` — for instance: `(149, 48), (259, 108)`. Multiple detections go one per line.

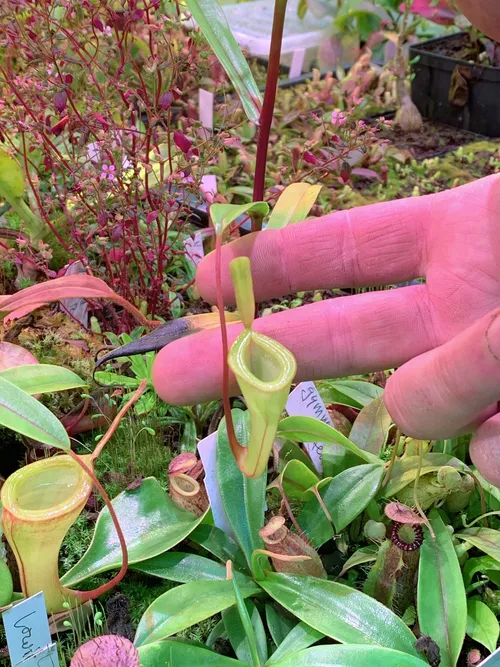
(0, 364), (87, 396)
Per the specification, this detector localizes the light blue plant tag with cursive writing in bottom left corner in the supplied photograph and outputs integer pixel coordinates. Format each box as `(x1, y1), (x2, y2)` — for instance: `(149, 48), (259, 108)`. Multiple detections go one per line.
(3, 592), (59, 667)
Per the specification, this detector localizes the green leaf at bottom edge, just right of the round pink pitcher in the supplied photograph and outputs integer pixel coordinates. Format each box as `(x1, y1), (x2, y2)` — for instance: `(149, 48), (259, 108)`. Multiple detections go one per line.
(138, 639), (250, 667)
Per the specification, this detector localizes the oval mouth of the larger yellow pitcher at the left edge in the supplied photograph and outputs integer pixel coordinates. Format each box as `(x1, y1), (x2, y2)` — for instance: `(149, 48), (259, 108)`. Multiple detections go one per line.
(1, 455), (92, 521)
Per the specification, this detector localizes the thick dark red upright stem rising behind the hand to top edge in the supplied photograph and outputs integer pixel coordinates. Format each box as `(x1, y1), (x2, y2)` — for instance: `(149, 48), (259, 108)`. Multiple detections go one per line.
(252, 0), (287, 226)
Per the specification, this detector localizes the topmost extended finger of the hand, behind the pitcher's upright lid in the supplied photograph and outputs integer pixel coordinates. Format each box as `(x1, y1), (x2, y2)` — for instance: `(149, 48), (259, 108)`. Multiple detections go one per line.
(196, 195), (430, 303)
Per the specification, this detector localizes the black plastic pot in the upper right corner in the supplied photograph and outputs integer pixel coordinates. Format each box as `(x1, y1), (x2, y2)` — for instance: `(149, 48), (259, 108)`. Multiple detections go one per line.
(410, 33), (500, 137)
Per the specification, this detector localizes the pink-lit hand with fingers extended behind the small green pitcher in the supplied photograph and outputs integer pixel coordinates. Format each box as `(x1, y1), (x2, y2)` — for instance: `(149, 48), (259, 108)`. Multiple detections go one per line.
(153, 176), (500, 485)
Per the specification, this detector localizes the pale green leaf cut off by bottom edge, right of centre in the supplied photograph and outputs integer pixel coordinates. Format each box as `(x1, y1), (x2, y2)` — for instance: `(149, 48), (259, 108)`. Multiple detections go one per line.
(268, 645), (427, 667)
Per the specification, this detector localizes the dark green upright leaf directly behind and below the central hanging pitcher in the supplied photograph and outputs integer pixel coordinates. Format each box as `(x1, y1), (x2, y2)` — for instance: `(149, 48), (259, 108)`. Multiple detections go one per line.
(216, 410), (267, 563)
